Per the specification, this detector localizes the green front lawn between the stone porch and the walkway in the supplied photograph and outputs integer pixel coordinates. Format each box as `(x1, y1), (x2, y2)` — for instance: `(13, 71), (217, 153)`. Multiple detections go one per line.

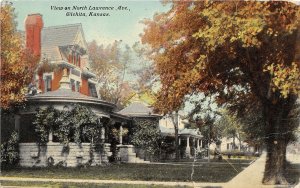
(1, 163), (248, 182)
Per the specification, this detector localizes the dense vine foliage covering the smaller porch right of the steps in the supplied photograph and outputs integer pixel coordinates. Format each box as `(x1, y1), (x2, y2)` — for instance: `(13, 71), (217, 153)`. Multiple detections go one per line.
(131, 118), (162, 155)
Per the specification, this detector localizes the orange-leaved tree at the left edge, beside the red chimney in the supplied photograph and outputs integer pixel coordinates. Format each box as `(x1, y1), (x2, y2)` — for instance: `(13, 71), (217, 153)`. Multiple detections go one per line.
(0, 3), (39, 109)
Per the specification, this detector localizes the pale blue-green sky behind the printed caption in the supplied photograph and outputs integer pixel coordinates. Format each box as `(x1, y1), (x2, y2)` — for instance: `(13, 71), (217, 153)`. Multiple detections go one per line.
(12, 0), (168, 46)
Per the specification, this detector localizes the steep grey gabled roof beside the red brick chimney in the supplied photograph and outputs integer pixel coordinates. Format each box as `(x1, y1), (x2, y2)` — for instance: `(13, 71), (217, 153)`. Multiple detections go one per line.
(41, 24), (86, 60)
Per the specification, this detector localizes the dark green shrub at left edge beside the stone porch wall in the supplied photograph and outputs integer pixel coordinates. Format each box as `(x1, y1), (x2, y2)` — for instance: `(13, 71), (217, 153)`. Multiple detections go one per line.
(1, 131), (19, 166)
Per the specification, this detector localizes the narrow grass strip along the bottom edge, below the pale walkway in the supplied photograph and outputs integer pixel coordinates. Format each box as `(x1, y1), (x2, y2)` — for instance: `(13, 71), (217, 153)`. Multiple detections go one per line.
(0, 181), (187, 188)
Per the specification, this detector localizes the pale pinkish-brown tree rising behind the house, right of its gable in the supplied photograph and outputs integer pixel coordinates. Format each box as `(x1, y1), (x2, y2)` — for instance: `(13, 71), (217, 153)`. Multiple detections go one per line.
(88, 41), (131, 106)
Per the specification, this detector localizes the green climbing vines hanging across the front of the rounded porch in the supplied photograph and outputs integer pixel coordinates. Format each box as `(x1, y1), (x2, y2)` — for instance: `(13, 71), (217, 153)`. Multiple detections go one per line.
(34, 104), (102, 146)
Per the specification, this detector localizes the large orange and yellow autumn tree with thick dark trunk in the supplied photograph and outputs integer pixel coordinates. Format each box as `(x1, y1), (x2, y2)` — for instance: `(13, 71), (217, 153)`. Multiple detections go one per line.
(142, 1), (300, 184)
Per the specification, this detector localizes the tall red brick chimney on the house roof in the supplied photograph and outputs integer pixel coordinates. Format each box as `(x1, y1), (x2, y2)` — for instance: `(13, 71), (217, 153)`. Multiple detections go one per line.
(25, 14), (44, 56)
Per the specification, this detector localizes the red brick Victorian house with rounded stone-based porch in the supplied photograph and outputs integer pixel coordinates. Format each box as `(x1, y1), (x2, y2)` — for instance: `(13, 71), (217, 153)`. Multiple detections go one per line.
(14, 14), (202, 166)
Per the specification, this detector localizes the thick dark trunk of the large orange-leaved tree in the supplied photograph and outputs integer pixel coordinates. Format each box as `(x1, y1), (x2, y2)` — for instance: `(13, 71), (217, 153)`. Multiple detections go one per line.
(263, 101), (293, 185)
